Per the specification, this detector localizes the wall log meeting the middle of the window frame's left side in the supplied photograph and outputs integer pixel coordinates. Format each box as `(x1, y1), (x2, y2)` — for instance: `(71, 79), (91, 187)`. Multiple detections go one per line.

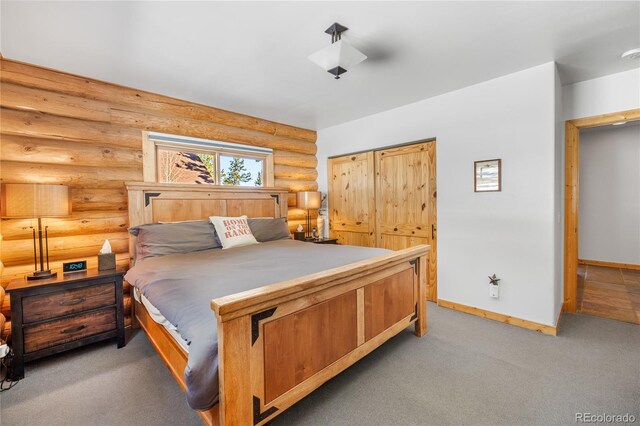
(0, 135), (142, 167)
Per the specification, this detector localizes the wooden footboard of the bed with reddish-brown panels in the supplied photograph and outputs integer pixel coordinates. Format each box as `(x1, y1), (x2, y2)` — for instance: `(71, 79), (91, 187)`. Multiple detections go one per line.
(211, 245), (430, 425)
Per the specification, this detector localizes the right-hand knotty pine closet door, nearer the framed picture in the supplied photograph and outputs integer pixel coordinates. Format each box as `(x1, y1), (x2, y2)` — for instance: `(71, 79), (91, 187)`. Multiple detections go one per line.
(375, 141), (437, 301)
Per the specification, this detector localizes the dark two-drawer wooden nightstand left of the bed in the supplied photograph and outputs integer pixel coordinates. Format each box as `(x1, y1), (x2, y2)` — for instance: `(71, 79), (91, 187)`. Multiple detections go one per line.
(6, 268), (125, 379)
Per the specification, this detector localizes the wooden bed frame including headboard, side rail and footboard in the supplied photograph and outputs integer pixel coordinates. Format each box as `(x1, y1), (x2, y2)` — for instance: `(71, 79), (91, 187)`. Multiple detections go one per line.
(126, 183), (430, 425)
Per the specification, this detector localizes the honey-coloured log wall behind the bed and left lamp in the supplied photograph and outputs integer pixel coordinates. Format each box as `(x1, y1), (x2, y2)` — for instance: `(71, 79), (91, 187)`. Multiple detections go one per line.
(0, 59), (318, 287)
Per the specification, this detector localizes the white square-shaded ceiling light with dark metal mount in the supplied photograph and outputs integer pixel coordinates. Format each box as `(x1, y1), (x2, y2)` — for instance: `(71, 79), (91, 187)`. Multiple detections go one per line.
(309, 22), (367, 80)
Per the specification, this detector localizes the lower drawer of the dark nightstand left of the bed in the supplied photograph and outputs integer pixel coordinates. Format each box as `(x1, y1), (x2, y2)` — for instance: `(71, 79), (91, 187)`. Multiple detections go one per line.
(24, 308), (116, 353)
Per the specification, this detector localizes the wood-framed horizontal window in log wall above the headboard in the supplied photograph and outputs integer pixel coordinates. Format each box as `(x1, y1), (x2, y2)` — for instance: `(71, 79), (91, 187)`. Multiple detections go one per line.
(143, 133), (273, 186)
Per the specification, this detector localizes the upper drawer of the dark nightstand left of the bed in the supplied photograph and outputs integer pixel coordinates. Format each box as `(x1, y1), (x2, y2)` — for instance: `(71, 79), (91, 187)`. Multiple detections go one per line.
(22, 283), (116, 324)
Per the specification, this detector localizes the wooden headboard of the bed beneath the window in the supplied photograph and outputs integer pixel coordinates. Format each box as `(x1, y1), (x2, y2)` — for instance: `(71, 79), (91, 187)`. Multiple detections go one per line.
(125, 182), (288, 264)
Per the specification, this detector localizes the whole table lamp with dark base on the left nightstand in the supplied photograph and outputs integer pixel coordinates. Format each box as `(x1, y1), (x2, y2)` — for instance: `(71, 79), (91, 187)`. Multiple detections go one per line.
(0, 183), (71, 280)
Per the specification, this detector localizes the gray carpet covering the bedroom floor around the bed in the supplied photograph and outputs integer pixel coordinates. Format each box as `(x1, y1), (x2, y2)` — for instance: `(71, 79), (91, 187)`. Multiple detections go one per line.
(0, 304), (640, 426)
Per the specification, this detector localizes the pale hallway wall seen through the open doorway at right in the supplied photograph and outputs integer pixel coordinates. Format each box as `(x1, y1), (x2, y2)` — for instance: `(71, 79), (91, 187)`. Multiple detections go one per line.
(578, 122), (640, 265)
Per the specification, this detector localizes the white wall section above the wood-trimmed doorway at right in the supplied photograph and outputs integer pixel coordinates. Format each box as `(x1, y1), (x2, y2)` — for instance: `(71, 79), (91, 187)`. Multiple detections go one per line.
(562, 68), (640, 120)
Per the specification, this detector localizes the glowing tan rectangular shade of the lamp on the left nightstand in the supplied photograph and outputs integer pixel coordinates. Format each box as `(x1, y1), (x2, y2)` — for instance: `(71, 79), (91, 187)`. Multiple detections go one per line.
(0, 183), (71, 218)
